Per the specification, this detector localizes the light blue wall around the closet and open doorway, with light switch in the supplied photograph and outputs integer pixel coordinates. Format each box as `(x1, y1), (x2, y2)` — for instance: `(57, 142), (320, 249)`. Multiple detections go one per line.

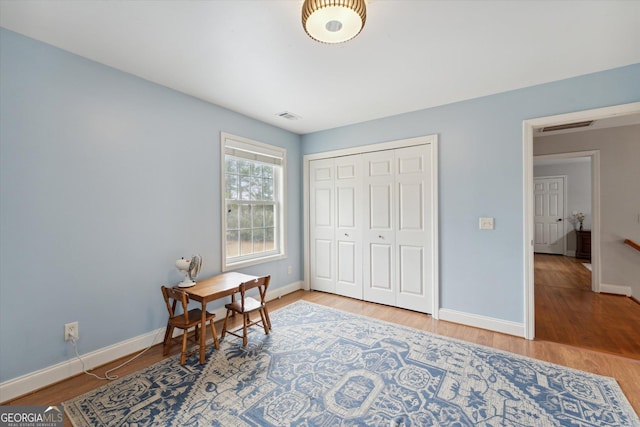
(302, 64), (640, 323)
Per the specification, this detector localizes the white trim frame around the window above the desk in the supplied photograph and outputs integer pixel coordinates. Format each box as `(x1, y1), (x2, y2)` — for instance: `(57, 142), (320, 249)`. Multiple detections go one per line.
(220, 132), (287, 271)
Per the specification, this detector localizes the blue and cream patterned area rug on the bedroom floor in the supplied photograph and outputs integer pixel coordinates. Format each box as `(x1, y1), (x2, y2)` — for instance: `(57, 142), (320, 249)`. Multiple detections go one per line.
(64, 301), (640, 427)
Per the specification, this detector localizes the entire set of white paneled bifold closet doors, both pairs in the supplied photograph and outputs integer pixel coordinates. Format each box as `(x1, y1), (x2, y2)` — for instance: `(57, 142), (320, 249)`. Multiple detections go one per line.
(309, 144), (435, 313)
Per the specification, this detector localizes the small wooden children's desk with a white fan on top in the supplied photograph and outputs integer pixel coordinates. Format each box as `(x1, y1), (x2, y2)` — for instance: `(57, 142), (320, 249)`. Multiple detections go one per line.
(180, 271), (258, 363)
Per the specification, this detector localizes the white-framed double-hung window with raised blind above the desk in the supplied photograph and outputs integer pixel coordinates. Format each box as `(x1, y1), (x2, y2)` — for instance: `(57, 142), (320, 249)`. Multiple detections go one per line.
(221, 133), (286, 271)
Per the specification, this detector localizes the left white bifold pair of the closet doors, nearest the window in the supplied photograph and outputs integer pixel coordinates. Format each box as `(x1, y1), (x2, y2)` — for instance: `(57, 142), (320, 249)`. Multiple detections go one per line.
(309, 155), (362, 299)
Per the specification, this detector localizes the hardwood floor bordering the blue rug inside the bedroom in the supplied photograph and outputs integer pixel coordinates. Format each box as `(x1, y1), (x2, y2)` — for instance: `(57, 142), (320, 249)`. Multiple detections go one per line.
(5, 291), (640, 425)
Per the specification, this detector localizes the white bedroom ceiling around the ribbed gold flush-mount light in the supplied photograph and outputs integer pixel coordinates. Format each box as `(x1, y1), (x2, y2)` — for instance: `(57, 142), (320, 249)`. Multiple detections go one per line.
(0, 0), (640, 134)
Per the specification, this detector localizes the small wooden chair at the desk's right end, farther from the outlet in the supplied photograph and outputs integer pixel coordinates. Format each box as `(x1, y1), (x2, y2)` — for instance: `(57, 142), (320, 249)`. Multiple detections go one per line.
(221, 276), (271, 346)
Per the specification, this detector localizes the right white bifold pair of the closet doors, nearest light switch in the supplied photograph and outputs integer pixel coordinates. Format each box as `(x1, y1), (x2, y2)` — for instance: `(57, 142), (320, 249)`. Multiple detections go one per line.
(363, 145), (434, 313)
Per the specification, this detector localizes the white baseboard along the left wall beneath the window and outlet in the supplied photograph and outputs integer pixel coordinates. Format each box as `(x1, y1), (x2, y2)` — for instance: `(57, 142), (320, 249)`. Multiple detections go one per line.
(0, 280), (304, 403)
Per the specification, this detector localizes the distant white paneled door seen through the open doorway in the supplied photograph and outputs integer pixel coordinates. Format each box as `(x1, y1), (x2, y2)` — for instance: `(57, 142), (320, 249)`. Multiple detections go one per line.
(533, 177), (565, 255)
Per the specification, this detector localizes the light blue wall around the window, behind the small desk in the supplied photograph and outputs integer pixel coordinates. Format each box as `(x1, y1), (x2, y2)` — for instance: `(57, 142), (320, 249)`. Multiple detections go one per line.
(0, 29), (302, 381)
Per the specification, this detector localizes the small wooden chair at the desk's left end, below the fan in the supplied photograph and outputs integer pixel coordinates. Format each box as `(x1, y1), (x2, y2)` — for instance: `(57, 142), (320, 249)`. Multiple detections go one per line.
(162, 286), (218, 365)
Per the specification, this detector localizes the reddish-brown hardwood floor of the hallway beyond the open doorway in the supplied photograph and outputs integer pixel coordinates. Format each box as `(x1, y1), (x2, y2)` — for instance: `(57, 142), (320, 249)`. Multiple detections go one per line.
(534, 254), (640, 360)
